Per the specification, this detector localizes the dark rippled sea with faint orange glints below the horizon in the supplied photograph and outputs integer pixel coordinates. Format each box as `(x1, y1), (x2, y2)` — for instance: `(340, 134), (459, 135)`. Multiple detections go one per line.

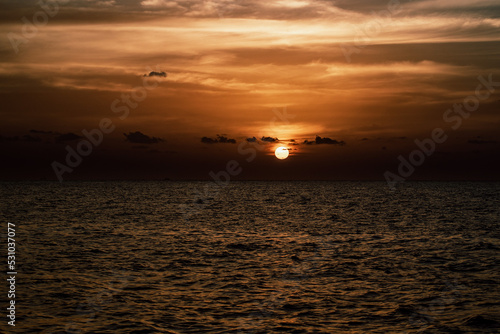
(0, 182), (500, 333)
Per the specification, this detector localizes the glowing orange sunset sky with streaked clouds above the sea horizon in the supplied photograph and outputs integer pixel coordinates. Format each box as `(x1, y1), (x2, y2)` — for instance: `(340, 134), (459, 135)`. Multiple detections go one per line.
(0, 0), (500, 180)
